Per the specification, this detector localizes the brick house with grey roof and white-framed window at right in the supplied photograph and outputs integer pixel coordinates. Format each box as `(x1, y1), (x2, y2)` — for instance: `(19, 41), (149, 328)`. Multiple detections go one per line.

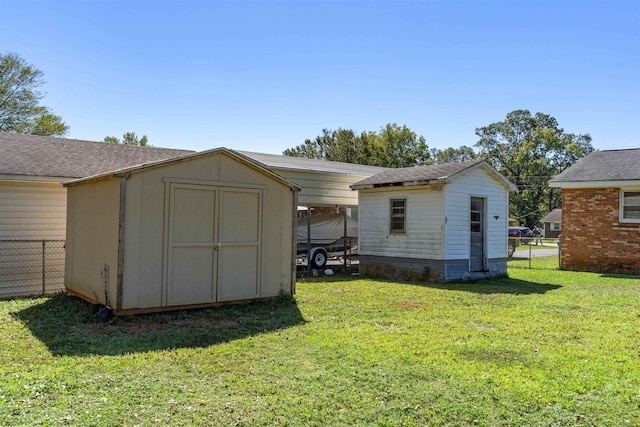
(549, 148), (640, 274)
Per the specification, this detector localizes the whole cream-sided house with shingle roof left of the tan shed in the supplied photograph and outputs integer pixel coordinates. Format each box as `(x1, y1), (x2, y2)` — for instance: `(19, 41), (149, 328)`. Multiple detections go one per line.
(0, 132), (193, 298)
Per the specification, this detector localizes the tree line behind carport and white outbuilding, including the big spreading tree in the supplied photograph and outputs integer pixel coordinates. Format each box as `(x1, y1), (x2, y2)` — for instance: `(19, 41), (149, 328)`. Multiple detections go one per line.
(283, 110), (593, 227)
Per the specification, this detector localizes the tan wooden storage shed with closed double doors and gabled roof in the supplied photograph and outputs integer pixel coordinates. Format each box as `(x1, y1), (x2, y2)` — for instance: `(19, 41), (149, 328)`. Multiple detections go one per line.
(65, 148), (300, 314)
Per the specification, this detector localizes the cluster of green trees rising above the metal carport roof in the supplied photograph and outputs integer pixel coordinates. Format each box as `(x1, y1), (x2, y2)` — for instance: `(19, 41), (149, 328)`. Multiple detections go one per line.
(283, 123), (429, 167)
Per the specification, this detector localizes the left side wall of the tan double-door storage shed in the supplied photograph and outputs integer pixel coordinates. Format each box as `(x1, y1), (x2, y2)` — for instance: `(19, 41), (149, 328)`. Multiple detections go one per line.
(64, 178), (120, 305)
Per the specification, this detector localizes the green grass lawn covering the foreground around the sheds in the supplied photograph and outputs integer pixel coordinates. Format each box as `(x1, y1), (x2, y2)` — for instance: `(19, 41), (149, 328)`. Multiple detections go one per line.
(0, 263), (640, 426)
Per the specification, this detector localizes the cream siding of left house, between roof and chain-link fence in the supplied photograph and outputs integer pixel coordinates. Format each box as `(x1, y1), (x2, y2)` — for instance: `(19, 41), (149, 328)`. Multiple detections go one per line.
(0, 181), (67, 240)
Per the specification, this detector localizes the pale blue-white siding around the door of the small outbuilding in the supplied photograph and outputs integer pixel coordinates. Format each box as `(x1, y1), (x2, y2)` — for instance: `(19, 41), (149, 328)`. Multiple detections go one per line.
(444, 168), (509, 259)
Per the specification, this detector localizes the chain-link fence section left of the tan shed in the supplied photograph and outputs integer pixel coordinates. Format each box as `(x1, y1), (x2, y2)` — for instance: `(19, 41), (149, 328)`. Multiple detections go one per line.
(0, 240), (65, 298)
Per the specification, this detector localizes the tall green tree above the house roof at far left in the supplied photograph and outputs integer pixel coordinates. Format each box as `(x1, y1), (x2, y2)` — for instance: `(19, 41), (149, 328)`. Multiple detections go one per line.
(0, 53), (69, 136)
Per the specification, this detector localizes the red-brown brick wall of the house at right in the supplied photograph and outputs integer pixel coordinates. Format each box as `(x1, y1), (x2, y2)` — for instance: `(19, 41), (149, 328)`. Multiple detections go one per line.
(560, 188), (640, 274)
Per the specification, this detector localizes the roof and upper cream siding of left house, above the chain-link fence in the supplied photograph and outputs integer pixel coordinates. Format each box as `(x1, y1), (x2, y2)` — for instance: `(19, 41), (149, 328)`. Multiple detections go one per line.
(0, 132), (193, 240)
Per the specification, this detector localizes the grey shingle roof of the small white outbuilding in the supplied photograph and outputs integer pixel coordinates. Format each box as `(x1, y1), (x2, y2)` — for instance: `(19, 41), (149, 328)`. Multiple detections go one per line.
(351, 160), (510, 190)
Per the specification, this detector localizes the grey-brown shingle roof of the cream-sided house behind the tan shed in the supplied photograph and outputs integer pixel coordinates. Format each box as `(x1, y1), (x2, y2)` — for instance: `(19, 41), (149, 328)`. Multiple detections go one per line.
(0, 132), (194, 178)
